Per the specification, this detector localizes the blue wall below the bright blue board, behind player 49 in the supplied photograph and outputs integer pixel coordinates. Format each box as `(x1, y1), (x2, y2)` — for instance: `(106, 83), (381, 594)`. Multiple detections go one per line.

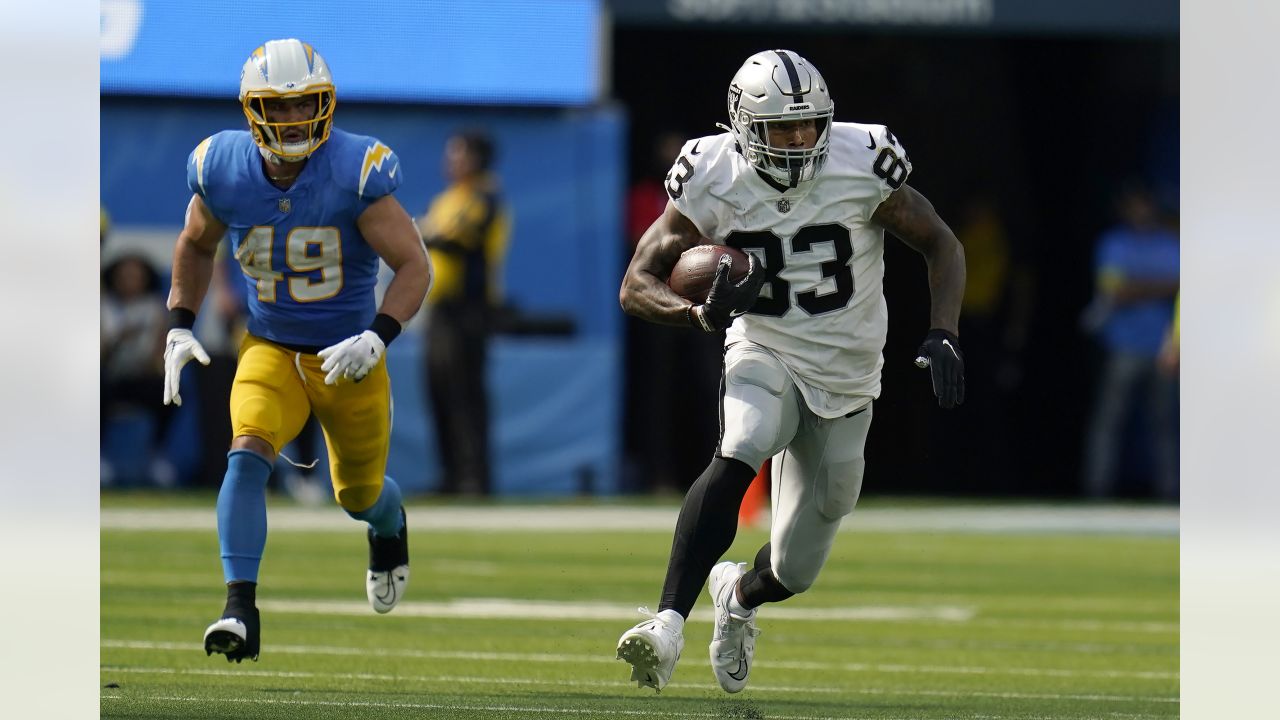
(101, 96), (626, 495)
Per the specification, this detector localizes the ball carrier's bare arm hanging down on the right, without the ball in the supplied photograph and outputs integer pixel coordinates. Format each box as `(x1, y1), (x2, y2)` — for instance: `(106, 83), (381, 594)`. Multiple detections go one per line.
(872, 184), (965, 334)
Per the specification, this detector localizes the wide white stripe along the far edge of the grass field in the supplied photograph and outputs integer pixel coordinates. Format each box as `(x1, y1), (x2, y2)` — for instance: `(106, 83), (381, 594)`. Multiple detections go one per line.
(99, 505), (1178, 536)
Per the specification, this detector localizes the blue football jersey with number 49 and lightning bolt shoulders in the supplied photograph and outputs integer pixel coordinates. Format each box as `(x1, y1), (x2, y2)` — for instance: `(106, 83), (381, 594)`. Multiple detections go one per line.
(187, 128), (401, 346)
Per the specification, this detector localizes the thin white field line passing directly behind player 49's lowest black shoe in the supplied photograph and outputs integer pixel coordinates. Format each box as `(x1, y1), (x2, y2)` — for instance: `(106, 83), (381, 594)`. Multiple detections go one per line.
(102, 639), (1178, 676)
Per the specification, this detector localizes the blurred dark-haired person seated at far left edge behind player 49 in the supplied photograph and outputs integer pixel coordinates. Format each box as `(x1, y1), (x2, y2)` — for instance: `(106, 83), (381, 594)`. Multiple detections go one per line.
(100, 252), (175, 486)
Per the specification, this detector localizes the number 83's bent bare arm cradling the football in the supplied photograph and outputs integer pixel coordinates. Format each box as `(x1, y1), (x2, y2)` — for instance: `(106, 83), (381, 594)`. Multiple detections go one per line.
(618, 201), (703, 325)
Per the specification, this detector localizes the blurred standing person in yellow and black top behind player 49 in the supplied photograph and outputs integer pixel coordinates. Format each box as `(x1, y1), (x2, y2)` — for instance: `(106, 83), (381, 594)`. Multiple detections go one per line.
(419, 131), (511, 495)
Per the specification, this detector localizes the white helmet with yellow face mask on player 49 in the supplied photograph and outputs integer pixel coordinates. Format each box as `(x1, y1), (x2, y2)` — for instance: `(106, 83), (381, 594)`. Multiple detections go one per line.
(239, 38), (337, 161)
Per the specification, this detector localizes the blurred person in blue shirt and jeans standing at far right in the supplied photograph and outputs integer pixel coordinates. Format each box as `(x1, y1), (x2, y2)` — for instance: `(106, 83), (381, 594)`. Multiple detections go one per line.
(1083, 182), (1179, 500)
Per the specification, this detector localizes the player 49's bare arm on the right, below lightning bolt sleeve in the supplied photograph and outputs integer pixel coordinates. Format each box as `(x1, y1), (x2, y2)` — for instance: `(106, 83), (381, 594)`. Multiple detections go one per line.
(356, 195), (431, 324)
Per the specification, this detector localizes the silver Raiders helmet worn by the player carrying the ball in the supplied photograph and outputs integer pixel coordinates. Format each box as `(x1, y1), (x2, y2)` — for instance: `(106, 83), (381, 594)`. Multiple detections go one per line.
(722, 50), (836, 187)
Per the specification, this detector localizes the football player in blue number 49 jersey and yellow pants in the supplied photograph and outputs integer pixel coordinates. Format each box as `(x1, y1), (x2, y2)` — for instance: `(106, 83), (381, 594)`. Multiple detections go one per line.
(164, 40), (431, 662)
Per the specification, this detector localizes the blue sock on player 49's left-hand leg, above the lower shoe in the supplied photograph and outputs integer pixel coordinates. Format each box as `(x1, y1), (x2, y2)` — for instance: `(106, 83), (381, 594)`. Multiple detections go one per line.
(218, 450), (271, 583)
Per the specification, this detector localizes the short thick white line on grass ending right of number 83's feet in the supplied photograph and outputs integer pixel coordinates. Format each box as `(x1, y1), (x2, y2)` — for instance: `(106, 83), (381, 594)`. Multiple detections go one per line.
(257, 597), (974, 623)
